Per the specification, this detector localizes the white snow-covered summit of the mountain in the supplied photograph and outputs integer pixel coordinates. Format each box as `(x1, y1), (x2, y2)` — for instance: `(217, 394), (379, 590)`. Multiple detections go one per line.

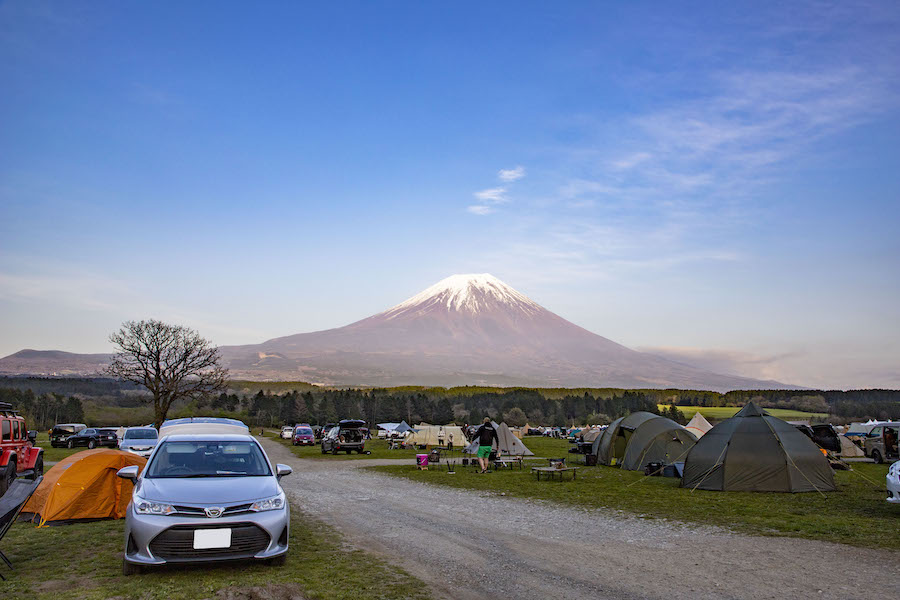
(384, 273), (542, 318)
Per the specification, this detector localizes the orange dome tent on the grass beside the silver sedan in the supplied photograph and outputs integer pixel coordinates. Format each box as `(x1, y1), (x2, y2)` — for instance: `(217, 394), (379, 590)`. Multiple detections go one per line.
(22, 449), (147, 525)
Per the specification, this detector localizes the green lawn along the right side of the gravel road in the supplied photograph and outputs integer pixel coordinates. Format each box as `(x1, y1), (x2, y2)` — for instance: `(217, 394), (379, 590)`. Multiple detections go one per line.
(375, 460), (900, 550)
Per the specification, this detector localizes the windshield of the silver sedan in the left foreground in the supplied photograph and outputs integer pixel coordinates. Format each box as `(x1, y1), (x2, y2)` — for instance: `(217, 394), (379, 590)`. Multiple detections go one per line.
(145, 441), (272, 479)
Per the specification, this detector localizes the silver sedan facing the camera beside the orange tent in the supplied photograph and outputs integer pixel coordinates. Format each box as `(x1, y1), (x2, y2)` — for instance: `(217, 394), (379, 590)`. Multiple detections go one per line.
(118, 434), (291, 575)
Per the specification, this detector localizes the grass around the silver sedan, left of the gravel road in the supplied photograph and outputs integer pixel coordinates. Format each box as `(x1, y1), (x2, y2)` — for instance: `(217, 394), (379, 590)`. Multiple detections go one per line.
(0, 507), (430, 600)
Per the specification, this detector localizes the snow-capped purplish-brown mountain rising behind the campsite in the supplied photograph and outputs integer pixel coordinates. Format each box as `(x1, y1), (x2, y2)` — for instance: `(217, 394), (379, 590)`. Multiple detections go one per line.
(221, 273), (785, 390)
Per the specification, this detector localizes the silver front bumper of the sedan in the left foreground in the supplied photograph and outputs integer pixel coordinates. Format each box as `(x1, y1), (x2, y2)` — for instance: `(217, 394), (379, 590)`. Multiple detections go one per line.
(125, 504), (291, 565)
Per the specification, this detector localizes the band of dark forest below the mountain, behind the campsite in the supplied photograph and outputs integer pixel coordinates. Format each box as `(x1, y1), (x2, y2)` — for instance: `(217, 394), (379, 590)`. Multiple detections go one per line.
(0, 377), (900, 429)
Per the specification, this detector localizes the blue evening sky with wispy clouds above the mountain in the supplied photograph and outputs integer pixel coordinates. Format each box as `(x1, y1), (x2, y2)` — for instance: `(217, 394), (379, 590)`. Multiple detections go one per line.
(0, 1), (900, 388)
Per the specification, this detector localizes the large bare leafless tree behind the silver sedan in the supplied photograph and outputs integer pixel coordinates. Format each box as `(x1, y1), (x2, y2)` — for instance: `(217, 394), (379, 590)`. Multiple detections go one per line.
(107, 319), (228, 427)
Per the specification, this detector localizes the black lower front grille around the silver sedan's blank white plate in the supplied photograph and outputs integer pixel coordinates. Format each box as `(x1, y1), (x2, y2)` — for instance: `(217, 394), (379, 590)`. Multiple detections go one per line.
(150, 523), (269, 562)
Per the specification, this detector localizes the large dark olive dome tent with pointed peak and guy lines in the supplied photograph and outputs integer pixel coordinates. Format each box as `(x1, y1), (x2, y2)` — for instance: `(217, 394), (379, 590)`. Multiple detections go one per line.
(681, 402), (835, 492)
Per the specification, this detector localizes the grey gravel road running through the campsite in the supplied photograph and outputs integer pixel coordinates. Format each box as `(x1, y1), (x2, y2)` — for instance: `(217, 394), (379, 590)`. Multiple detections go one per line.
(264, 441), (900, 600)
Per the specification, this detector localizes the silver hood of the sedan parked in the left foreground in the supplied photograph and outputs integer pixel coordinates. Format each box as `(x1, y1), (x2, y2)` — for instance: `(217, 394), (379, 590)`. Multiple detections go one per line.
(135, 475), (281, 504)
